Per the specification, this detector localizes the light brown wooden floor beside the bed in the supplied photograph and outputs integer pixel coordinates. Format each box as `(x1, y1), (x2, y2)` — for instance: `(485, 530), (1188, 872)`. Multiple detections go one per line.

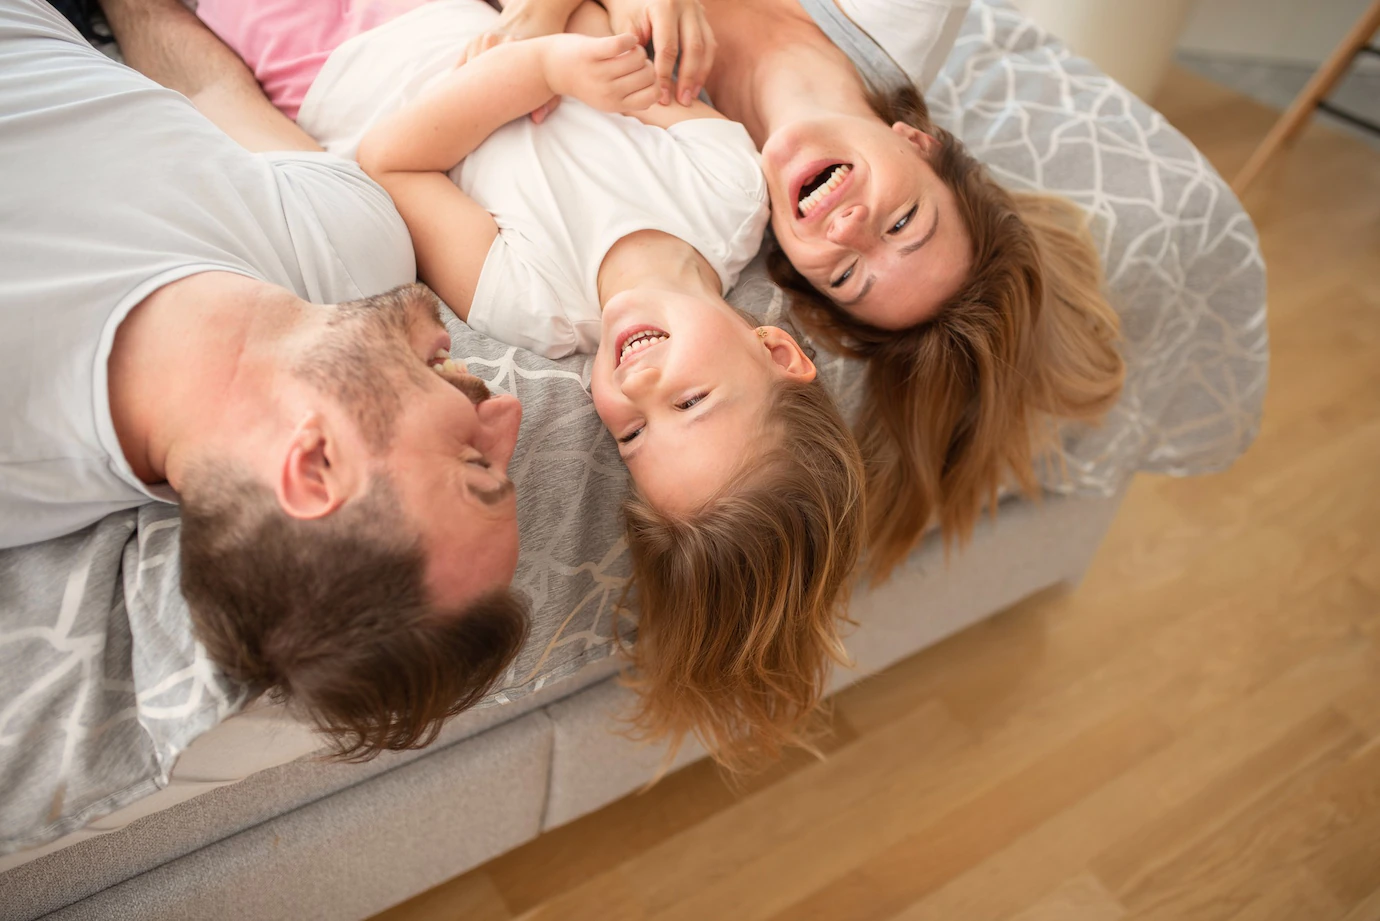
(380, 73), (1380, 921)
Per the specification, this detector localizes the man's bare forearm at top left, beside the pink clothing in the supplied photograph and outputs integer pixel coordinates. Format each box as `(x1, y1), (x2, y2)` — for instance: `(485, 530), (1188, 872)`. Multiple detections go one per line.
(101, 0), (322, 151)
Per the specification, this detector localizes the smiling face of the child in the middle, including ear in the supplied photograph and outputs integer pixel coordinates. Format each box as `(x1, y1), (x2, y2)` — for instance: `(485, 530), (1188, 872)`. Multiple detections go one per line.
(591, 290), (814, 514)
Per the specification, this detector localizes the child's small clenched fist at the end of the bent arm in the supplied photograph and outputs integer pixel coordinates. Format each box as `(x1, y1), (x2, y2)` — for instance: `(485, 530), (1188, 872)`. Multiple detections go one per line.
(542, 33), (660, 112)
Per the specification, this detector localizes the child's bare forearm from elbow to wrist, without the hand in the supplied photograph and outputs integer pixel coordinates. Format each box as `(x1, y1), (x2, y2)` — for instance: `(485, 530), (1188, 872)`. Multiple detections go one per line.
(359, 39), (553, 177)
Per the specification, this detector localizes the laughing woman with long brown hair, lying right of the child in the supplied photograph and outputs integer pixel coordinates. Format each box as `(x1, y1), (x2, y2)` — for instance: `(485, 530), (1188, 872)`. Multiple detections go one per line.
(480, 0), (1125, 579)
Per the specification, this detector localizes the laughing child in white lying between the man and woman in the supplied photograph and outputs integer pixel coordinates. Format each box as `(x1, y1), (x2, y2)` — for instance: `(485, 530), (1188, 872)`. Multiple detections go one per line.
(201, 0), (863, 766)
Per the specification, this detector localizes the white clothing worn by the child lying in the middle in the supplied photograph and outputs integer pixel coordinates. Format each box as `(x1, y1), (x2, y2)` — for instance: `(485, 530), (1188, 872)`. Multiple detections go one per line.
(298, 0), (769, 358)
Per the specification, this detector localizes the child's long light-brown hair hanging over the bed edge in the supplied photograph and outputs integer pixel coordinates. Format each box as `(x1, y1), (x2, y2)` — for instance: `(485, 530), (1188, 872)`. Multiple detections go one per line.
(624, 381), (864, 770)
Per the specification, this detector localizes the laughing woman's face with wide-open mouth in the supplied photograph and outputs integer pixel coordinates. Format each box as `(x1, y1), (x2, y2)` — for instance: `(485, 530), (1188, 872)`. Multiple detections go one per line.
(762, 116), (972, 330)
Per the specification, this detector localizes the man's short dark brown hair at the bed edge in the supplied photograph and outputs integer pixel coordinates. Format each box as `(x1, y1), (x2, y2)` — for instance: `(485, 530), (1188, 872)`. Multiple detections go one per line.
(181, 465), (527, 761)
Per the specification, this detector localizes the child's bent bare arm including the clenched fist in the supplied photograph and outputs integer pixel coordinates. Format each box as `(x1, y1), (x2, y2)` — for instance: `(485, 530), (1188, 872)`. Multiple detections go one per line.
(359, 35), (657, 319)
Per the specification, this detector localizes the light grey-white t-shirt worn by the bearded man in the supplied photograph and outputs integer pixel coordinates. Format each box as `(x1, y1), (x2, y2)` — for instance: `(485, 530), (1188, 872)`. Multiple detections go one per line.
(0, 0), (415, 548)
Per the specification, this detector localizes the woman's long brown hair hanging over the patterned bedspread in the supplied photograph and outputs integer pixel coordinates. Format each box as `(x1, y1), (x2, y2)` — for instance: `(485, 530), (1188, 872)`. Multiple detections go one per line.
(769, 82), (1125, 580)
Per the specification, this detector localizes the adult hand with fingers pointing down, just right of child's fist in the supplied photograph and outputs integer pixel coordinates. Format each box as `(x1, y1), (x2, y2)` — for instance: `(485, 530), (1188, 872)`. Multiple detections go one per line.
(603, 0), (716, 105)
